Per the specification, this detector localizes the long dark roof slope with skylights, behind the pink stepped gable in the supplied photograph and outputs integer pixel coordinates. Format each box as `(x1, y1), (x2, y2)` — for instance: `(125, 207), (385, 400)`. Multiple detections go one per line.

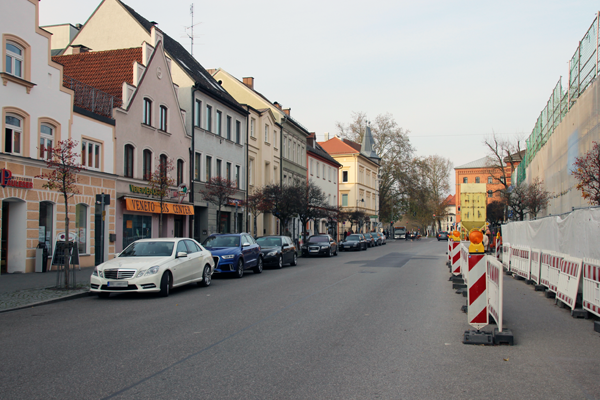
(118, 0), (247, 114)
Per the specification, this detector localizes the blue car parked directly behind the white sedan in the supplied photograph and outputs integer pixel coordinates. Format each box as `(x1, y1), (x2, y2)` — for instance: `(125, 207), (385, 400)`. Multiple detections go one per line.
(202, 233), (263, 278)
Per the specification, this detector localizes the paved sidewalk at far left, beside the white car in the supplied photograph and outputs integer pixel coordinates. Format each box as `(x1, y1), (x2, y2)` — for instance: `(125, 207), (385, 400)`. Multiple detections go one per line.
(0, 267), (94, 312)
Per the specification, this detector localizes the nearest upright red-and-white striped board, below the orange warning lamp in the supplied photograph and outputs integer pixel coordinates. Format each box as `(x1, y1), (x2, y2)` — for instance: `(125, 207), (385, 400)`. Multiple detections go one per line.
(463, 253), (489, 330)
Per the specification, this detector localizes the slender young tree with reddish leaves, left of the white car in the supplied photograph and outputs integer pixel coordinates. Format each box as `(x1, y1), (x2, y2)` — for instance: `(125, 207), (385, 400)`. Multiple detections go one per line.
(36, 138), (85, 289)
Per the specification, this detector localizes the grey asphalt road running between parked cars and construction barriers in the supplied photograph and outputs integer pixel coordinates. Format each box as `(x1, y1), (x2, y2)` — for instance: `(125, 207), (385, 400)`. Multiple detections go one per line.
(0, 239), (600, 399)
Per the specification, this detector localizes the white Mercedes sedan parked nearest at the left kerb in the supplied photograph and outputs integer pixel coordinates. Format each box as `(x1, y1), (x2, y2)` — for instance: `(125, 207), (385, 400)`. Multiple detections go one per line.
(90, 238), (215, 298)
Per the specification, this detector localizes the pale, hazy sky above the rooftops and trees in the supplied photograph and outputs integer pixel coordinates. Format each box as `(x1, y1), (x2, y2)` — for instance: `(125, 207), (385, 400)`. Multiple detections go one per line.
(40, 0), (600, 192)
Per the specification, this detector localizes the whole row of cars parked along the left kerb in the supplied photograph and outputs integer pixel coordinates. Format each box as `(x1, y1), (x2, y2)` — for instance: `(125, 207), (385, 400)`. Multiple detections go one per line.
(90, 232), (386, 298)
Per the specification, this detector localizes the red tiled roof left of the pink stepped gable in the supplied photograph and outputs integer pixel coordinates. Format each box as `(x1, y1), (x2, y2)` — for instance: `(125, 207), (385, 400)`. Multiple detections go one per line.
(52, 47), (142, 107)
